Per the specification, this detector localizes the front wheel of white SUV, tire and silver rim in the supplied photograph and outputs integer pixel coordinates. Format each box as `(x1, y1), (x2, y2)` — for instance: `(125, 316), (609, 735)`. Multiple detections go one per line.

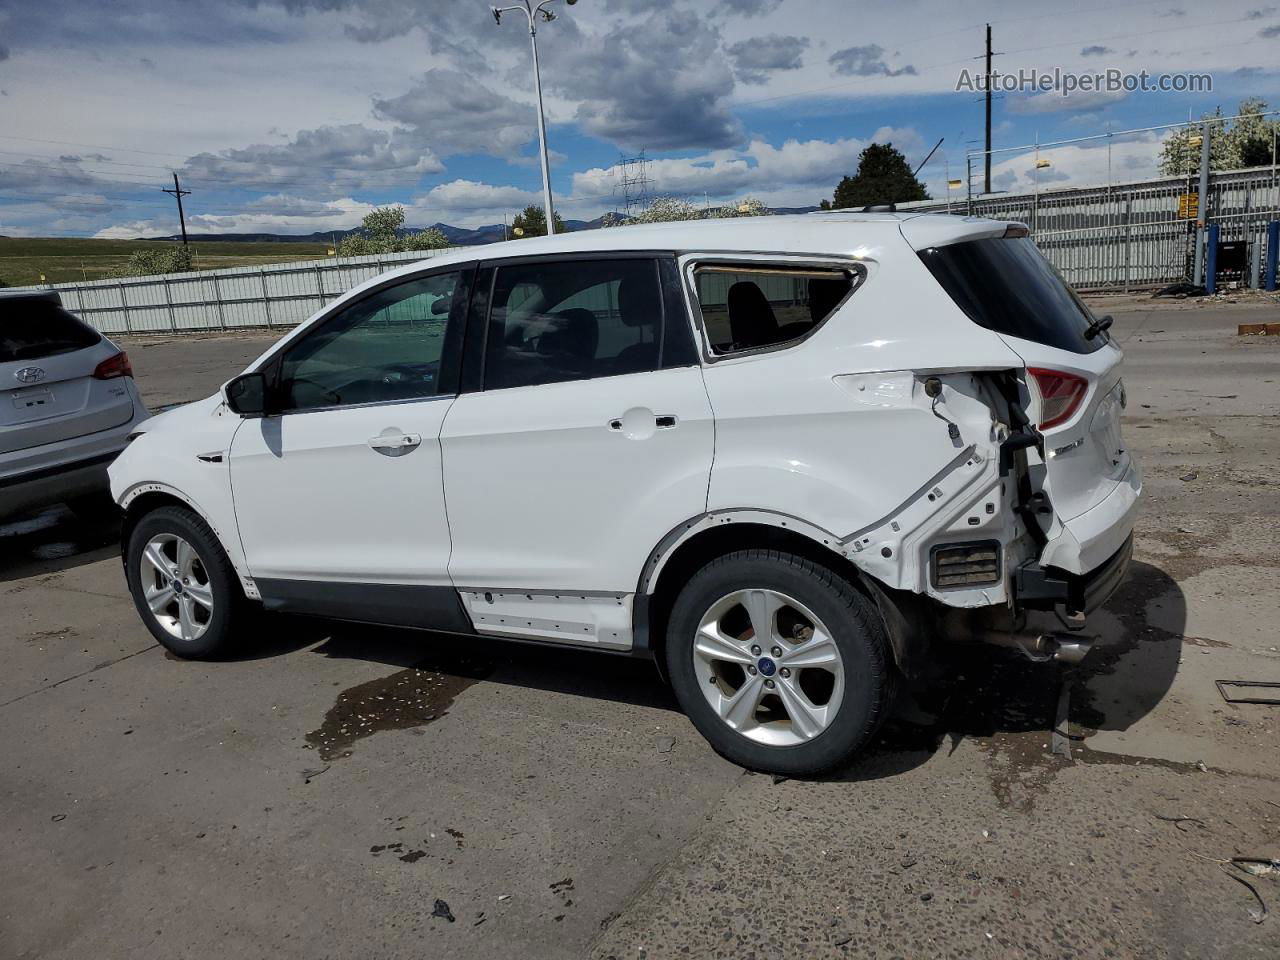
(125, 507), (247, 659)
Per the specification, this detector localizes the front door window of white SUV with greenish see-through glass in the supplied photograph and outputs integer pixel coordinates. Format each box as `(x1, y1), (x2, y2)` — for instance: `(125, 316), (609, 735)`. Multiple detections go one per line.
(279, 271), (466, 410)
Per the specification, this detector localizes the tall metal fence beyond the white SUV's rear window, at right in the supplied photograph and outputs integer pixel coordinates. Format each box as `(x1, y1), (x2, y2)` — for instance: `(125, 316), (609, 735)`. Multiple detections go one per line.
(899, 166), (1280, 291)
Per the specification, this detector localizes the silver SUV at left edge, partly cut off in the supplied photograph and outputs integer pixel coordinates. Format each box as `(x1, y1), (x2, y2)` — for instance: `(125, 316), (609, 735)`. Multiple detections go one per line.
(0, 291), (147, 517)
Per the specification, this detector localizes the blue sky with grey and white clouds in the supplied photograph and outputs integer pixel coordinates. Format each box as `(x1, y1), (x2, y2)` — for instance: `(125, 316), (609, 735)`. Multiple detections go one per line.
(0, 0), (1280, 237)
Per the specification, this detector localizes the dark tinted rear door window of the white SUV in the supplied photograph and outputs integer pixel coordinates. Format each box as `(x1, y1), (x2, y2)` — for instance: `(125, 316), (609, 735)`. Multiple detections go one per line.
(484, 260), (663, 390)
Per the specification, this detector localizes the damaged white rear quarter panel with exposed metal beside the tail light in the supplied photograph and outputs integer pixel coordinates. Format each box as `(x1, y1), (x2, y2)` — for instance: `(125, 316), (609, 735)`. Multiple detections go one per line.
(704, 244), (1021, 605)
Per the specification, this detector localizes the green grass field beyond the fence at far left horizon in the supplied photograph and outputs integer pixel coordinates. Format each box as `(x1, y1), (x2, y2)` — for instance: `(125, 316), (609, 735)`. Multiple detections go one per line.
(0, 237), (328, 287)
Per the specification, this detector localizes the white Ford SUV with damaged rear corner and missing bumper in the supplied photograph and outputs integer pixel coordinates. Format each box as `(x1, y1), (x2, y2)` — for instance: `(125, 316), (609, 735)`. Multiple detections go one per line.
(111, 211), (1140, 774)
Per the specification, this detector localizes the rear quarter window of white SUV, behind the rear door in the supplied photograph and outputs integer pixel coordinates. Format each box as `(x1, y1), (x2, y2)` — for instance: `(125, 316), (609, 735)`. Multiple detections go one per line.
(694, 266), (859, 353)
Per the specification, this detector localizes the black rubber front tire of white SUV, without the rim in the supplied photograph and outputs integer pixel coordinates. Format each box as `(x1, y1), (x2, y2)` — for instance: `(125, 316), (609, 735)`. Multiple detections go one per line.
(125, 506), (250, 660)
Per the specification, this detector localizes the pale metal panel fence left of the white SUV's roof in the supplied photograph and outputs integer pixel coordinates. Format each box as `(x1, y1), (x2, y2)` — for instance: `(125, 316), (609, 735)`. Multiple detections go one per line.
(8, 250), (460, 334)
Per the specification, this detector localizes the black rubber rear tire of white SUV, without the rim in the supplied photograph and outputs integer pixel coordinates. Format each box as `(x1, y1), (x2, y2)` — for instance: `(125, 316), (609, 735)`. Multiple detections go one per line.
(666, 550), (899, 777)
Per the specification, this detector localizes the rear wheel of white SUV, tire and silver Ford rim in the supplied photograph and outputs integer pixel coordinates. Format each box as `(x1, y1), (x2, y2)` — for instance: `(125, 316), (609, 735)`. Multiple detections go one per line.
(667, 550), (897, 776)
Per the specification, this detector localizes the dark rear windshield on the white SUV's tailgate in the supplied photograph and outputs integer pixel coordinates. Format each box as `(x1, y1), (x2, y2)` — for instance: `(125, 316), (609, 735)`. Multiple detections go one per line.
(920, 237), (1106, 353)
